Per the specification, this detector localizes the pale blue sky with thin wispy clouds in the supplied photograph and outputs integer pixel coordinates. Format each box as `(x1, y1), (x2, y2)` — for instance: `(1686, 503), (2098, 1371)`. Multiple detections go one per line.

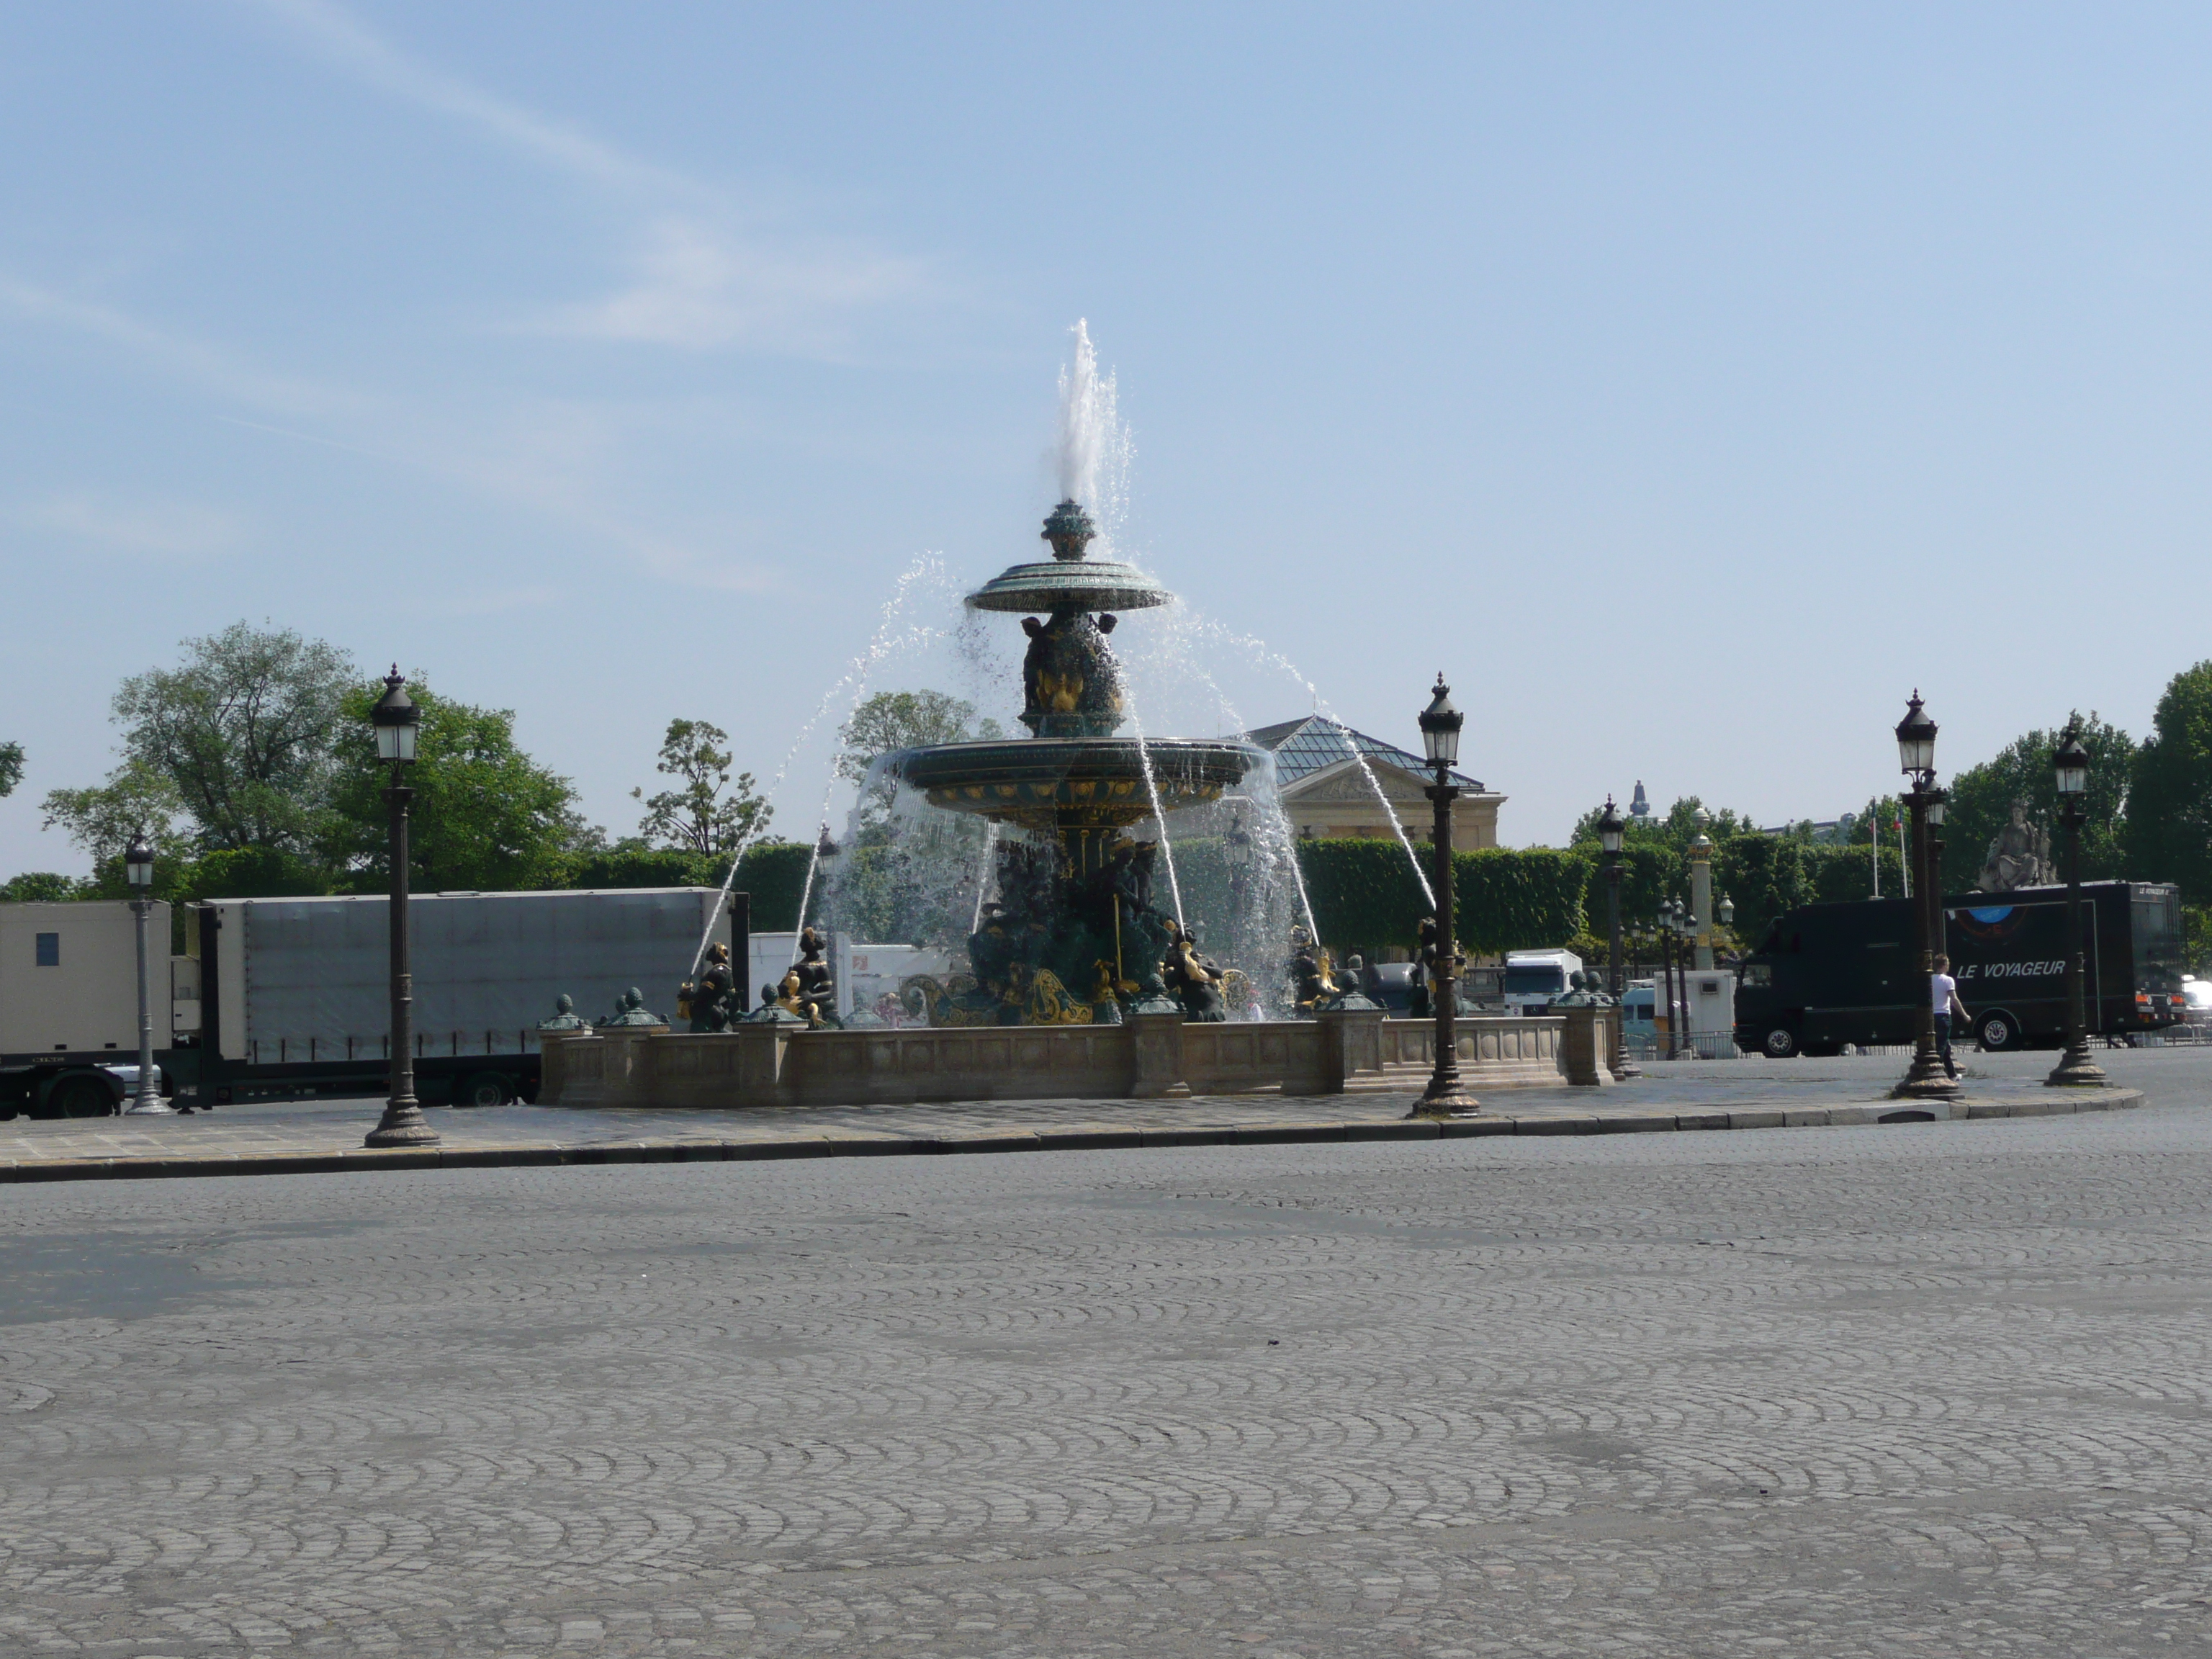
(0, 0), (2212, 873)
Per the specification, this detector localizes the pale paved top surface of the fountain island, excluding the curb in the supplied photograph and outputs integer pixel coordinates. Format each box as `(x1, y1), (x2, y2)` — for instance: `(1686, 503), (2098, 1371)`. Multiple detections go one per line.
(0, 1048), (2176, 1179)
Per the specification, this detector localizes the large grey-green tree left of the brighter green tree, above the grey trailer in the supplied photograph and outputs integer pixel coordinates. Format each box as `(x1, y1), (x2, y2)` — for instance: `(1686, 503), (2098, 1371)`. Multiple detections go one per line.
(111, 621), (359, 852)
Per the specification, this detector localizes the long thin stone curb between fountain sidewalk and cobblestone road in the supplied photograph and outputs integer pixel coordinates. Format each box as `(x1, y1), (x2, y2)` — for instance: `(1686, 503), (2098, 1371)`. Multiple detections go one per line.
(0, 1088), (2144, 1184)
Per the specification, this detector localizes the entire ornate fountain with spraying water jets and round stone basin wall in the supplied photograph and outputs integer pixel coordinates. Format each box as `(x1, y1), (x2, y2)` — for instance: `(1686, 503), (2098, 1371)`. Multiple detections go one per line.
(540, 328), (1579, 1119)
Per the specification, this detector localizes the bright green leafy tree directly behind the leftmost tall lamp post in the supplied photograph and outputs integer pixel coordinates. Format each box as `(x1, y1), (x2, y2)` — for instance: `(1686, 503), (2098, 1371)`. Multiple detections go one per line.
(320, 681), (604, 891)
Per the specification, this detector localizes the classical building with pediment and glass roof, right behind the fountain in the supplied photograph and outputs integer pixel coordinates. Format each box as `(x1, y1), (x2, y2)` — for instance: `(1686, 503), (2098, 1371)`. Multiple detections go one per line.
(1246, 714), (1504, 852)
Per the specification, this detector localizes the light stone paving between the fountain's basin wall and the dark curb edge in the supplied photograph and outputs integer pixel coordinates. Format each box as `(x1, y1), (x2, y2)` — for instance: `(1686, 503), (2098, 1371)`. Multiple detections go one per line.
(0, 1048), (2176, 1181)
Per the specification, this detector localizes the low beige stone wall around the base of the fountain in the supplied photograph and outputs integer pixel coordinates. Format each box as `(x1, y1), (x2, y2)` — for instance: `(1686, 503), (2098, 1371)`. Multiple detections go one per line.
(537, 1011), (1604, 1108)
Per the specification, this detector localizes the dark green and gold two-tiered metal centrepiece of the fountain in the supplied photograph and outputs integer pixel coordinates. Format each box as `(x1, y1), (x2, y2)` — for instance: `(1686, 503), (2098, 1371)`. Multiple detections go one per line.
(889, 500), (1265, 1026)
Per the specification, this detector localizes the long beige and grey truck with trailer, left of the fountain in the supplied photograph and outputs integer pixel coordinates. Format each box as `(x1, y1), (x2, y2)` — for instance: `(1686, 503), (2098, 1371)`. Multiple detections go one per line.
(0, 887), (743, 1117)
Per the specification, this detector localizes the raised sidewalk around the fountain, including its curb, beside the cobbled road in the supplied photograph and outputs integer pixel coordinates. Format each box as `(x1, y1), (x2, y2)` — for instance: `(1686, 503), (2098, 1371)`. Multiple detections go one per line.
(0, 1059), (2144, 1184)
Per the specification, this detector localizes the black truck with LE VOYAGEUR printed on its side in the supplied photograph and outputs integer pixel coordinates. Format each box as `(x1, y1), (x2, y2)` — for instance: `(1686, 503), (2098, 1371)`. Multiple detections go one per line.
(1737, 881), (2185, 1059)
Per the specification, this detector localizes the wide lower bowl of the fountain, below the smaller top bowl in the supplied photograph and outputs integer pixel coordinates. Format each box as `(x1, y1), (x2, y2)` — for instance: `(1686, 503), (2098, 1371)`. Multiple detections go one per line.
(896, 737), (1265, 830)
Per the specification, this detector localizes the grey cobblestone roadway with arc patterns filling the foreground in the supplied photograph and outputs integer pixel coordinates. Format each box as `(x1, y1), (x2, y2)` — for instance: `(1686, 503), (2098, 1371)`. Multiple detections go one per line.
(0, 1055), (2212, 1659)
